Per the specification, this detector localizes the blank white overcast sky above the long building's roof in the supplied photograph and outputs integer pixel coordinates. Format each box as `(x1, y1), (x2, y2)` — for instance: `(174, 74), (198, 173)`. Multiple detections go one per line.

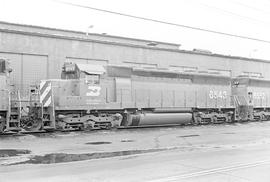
(0, 0), (270, 60)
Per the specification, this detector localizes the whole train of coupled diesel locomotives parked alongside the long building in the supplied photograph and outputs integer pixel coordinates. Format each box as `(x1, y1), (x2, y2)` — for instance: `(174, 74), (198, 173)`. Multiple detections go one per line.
(0, 61), (270, 132)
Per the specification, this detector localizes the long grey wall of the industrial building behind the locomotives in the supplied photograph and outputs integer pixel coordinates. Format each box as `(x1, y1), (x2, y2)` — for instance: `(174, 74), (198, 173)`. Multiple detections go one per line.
(0, 22), (270, 96)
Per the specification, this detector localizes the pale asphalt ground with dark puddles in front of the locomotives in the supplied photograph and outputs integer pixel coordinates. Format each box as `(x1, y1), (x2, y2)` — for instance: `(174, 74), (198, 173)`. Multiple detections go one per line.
(0, 122), (270, 182)
